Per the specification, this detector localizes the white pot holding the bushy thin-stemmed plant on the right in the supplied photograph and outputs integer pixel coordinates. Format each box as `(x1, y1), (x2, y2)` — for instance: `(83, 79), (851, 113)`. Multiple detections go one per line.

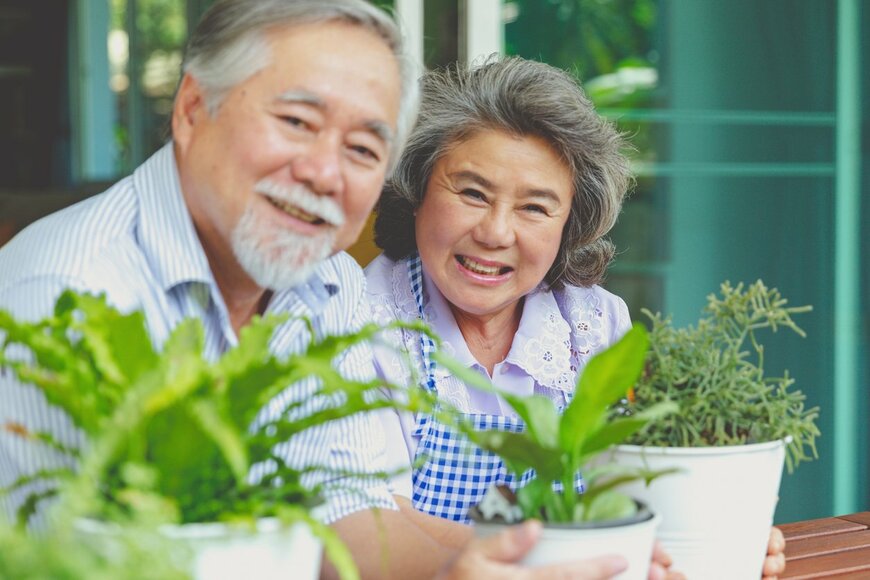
(605, 441), (786, 580)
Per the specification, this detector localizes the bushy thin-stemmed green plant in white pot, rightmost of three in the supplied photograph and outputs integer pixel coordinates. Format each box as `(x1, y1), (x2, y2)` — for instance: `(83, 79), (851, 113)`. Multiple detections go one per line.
(608, 280), (819, 579)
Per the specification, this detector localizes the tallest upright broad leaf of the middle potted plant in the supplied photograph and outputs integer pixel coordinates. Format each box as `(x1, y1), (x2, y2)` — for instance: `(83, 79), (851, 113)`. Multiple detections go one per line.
(559, 324), (649, 458)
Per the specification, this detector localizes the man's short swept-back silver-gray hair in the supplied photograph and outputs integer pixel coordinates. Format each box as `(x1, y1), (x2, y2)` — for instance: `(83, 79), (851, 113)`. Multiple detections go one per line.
(182, 0), (418, 170)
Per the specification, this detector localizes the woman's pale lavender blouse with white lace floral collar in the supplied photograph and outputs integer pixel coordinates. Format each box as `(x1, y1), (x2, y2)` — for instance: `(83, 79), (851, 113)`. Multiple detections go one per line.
(365, 255), (631, 497)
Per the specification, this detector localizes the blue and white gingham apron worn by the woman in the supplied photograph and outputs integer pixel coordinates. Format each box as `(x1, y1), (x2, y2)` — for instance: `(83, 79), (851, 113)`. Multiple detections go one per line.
(408, 255), (584, 523)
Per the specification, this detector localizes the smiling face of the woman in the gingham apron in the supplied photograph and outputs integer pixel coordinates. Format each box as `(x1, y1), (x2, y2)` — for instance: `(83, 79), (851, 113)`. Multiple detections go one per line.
(415, 130), (573, 317)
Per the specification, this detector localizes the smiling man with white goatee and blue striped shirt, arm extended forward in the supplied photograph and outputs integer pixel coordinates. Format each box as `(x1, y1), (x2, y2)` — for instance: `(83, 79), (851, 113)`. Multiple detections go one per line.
(0, 0), (636, 578)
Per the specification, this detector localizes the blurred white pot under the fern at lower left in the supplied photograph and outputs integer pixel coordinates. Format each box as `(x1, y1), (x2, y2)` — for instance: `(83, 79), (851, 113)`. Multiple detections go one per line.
(76, 518), (322, 580)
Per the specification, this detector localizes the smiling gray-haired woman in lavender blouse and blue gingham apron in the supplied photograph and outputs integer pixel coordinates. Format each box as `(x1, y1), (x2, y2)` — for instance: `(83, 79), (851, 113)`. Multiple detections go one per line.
(366, 58), (782, 574)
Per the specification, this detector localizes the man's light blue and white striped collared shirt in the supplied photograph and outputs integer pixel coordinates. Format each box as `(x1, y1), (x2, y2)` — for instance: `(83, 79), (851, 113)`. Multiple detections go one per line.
(0, 144), (395, 525)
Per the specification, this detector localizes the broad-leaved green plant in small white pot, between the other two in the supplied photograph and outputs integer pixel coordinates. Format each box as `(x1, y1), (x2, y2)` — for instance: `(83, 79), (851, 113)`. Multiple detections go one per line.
(436, 325), (673, 579)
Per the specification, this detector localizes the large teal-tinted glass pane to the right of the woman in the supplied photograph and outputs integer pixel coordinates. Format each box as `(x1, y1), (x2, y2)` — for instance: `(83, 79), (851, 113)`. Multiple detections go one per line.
(504, 0), (870, 521)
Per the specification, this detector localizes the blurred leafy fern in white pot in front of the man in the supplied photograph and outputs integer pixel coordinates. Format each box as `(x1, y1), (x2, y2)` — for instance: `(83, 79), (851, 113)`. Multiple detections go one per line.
(0, 292), (436, 578)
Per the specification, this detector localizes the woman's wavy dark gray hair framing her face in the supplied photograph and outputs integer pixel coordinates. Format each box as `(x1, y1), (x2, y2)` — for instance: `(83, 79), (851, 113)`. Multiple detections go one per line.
(375, 57), (632, 288)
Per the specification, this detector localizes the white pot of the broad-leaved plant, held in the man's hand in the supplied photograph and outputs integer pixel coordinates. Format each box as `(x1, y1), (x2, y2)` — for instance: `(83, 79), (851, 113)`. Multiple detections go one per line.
(474, 509), (661, 580)
